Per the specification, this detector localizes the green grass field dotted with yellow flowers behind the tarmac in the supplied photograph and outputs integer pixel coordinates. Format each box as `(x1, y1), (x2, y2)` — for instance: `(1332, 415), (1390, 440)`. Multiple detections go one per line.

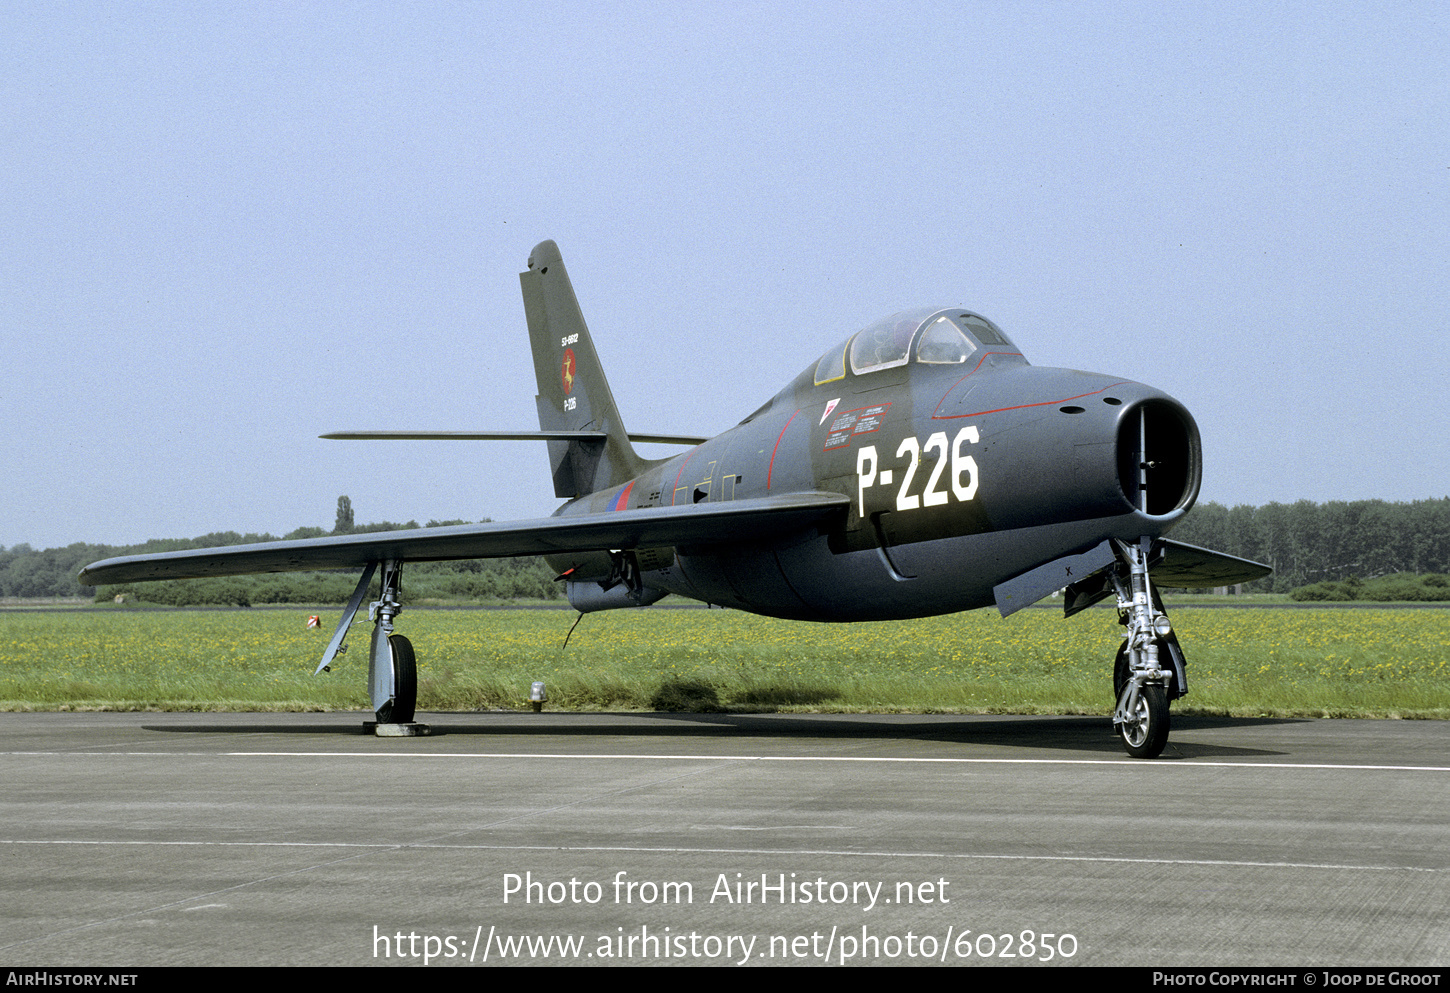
(0, 609), (1450, 718)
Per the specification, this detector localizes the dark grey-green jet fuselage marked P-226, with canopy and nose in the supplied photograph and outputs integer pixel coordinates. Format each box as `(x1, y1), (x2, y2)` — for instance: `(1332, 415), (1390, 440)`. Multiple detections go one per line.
(548, 309), (1201, 620)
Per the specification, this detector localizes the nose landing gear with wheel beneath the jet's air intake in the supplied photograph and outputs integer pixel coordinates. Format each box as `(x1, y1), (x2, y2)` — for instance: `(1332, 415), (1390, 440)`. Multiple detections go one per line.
(1108, 538), (1188, 758)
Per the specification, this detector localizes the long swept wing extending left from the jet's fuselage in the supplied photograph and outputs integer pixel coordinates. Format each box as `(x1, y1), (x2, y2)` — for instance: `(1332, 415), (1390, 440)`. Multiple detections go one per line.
(80, 493), (851, 586)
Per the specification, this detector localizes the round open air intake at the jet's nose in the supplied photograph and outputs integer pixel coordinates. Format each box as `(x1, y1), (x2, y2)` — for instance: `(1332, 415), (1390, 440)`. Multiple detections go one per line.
(1118, 399), (1202, 518)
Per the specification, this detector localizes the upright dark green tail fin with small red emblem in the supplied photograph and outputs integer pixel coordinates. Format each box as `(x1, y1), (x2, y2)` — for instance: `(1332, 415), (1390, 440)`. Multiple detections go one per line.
(519, 241), (650, 497)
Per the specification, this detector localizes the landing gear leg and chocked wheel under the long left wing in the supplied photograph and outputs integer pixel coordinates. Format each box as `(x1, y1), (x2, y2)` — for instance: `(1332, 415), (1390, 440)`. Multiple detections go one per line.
(318, 561), (432, 738)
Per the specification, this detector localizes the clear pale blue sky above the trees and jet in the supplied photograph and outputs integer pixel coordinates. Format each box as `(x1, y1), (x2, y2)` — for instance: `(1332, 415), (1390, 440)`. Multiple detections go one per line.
(0, 0), (1450, 548)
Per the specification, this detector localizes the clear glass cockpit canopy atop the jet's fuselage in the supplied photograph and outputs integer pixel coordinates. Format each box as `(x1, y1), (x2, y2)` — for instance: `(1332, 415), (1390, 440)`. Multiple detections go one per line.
(815, 307), (1016, 386)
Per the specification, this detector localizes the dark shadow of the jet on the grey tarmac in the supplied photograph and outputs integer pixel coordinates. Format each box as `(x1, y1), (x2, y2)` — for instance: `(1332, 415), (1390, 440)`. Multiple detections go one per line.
(146, 710), (1302, 761)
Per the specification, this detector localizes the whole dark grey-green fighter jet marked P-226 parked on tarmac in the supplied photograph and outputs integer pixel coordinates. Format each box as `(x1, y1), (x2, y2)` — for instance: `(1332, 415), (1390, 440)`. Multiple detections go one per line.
(81, 241), (1269, 757)
